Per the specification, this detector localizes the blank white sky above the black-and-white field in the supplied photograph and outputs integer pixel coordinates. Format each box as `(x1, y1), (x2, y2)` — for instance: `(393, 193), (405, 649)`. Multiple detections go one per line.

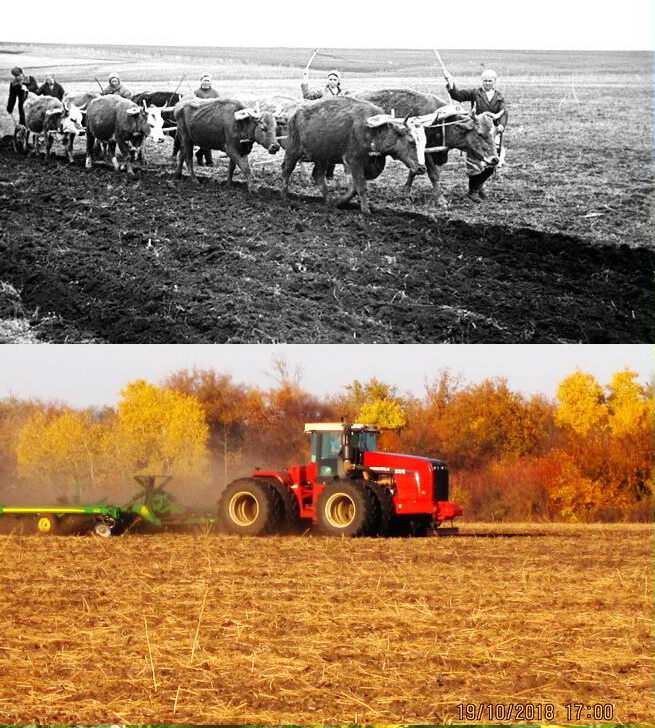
(0, 0), (655, 50)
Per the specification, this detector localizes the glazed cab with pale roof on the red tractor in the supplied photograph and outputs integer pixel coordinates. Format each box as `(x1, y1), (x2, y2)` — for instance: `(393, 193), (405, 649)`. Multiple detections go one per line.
(305, 422), (380, 481)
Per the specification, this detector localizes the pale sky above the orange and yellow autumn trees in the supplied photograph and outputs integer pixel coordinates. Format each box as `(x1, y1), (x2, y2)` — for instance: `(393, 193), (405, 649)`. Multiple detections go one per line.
(0, 344), (655, 407)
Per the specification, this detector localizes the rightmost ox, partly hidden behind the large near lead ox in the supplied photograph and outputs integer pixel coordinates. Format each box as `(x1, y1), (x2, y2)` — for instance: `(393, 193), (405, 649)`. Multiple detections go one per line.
(358, 89), (499, 205)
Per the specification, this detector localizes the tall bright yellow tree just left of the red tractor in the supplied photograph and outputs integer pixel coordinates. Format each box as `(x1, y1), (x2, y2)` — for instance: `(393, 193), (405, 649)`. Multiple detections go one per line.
(105, 380), (208, 480)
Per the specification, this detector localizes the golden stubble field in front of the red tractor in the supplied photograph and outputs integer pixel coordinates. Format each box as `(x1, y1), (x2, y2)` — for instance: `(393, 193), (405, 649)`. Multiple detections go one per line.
(0, 524), (655, 724)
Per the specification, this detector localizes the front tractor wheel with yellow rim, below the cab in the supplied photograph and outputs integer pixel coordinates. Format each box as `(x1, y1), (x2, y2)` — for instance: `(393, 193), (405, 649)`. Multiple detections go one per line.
(316, 480), (379, 536)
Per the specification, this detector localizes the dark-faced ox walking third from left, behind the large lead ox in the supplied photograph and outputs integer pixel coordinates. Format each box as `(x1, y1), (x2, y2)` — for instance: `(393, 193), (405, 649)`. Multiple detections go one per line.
(175, 99), (280, 189)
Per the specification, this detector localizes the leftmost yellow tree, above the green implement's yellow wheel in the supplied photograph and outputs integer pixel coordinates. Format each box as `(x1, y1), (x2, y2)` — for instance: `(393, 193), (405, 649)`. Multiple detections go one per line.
(16, 409), (102, 496)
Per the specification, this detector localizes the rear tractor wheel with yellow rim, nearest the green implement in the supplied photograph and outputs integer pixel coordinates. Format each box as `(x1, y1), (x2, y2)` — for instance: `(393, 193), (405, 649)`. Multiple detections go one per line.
(218, 478), (285, 536)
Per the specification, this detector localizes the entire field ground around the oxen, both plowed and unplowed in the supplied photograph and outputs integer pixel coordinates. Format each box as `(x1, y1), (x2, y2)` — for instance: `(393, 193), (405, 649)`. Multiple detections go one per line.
(0, 47), (655, 343)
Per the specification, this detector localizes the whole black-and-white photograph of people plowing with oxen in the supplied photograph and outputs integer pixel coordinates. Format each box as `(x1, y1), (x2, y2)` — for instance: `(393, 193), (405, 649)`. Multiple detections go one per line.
(0, 0), (655, 344)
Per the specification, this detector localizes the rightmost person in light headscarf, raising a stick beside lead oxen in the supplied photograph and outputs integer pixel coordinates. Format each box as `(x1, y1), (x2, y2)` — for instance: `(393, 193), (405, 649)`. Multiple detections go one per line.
(444, 68), (507, 202)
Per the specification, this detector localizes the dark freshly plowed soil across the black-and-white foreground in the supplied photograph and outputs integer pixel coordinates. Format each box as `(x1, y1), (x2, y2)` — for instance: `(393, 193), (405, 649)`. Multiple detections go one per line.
(0, 145), (655, 343)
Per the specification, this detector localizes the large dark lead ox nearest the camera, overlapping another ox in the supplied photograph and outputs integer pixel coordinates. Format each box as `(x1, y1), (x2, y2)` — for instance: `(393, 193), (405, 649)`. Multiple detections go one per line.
(282, 96), (425, 213)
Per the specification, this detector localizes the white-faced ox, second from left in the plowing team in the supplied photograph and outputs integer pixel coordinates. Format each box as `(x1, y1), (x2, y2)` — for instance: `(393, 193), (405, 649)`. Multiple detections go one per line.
(86, 94), (155, 176)
